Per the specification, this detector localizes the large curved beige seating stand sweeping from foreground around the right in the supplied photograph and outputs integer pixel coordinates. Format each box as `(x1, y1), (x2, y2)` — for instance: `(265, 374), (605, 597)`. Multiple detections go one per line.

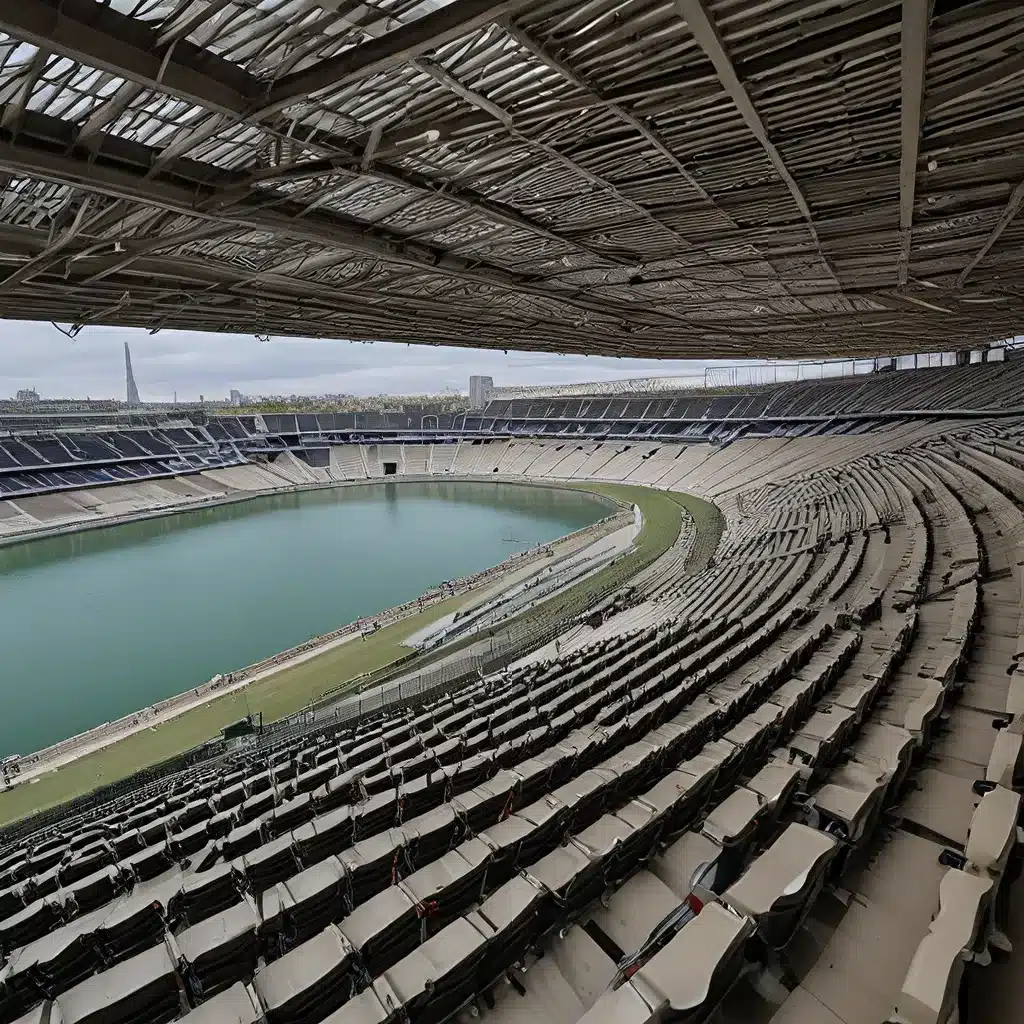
(0, 358), (1024, 1024)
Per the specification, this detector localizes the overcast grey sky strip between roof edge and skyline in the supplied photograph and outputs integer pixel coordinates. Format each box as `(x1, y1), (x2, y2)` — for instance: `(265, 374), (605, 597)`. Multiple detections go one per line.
(0, 321), (745, 401)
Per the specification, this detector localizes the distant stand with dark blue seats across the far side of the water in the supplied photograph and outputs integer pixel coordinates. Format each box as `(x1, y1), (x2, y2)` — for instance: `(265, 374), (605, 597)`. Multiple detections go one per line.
(0, 362), (1024, 518)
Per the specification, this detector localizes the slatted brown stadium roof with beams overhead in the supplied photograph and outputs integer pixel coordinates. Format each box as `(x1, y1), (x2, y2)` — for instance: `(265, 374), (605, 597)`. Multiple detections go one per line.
(0, 0), (1024, 357)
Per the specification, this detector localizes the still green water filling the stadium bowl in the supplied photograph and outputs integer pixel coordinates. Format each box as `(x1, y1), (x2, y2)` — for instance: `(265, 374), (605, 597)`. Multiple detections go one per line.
(0, 481), (609, 756)
